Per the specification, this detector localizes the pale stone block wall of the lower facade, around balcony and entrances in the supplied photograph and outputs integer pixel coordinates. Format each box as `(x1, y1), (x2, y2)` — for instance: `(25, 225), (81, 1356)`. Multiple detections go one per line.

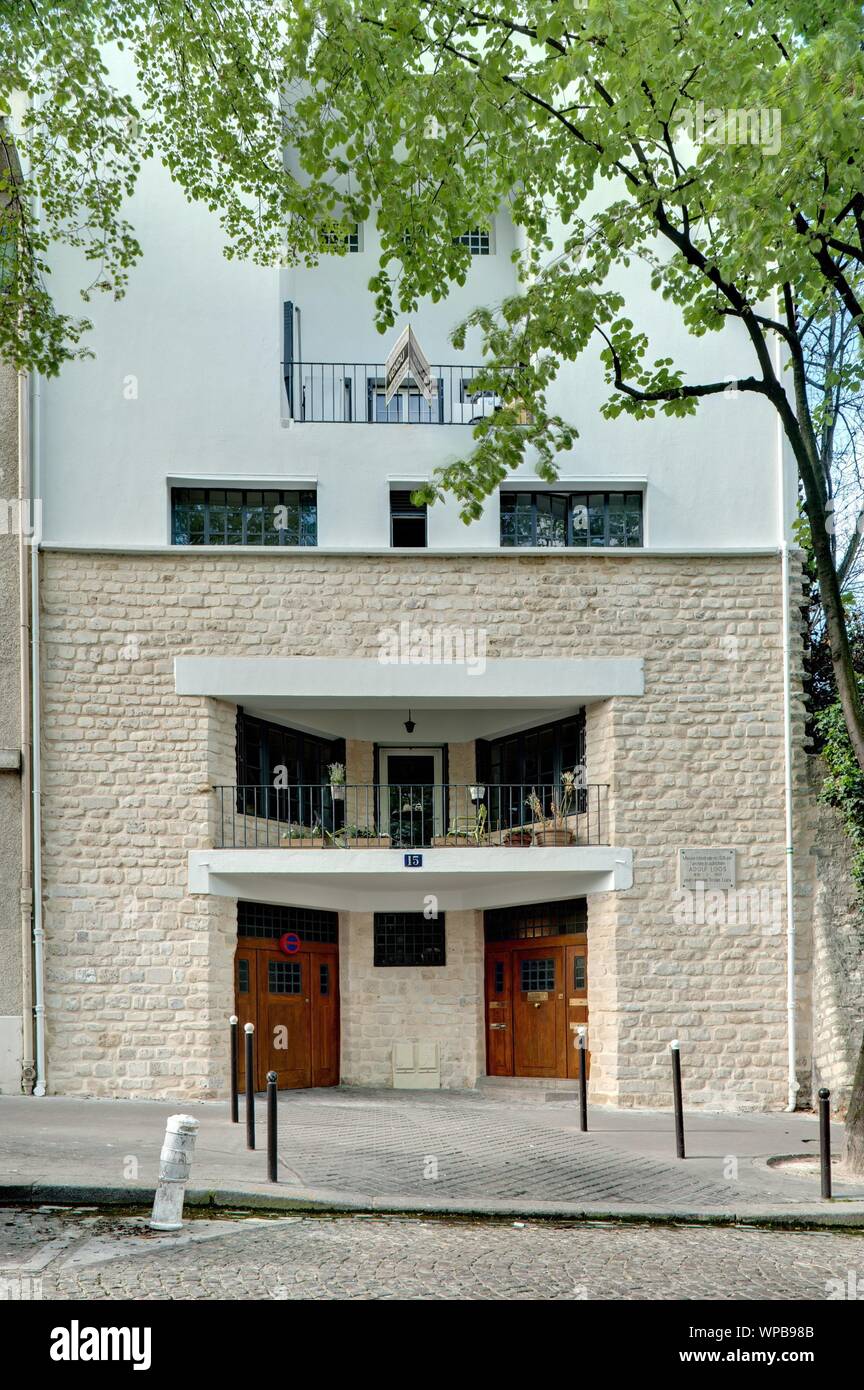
(43, 550), (803, 1108)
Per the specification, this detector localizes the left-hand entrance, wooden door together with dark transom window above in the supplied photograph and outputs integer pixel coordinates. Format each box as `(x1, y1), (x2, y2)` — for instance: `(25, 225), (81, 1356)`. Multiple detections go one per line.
(235, 902), (339, 1091)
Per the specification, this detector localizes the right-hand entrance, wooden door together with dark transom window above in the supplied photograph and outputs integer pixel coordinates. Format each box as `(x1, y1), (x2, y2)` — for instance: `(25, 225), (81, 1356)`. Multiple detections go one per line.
(485, 898), (590, 1077)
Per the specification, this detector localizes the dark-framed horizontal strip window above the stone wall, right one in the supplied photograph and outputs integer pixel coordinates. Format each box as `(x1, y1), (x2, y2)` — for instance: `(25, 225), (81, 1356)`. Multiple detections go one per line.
(500, 492), (642, 549)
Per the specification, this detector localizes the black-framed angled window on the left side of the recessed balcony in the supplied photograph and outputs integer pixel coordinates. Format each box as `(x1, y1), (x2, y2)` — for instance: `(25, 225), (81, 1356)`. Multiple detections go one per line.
(238, 710), (344, 831)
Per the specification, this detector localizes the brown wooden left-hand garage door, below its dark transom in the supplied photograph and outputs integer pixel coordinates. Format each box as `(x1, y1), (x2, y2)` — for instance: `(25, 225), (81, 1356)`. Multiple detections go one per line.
(235, 941), (339, 1091)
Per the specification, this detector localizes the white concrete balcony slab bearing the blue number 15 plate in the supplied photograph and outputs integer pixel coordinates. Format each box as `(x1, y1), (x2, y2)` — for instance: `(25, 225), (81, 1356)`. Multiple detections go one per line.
(189, 845), (633, 912)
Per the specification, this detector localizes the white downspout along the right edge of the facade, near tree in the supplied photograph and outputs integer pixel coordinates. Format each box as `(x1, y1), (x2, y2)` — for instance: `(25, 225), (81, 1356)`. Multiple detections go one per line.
(774, 304), (799, 1111)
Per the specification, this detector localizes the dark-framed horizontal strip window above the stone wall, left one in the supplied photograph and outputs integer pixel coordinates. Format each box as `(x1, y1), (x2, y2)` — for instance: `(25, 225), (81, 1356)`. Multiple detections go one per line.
(171, 488), (318, 545)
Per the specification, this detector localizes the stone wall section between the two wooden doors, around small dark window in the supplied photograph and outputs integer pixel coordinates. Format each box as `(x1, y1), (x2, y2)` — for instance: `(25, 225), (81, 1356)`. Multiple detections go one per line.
(339, 898), (485, 1088)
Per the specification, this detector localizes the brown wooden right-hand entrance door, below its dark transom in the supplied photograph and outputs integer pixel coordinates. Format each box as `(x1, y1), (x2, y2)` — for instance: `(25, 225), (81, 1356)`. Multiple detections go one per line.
(486, 933), (590, 1079)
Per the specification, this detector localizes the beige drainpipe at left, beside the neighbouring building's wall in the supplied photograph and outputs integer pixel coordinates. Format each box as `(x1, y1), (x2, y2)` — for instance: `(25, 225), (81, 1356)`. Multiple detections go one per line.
(18, 371), (35, 1094)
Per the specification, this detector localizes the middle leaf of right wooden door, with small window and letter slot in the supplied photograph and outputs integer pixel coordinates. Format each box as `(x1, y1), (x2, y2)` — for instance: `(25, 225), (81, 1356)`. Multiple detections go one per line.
(513, 947), (567, 1077)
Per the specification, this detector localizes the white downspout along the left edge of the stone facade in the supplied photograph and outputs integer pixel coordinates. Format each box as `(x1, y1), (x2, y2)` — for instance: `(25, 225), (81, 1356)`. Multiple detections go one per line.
(31, 374), (46, 1095)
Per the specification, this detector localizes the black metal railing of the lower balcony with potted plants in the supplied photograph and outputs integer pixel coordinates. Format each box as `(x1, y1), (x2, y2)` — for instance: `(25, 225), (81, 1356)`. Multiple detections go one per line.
(215, 783), (608, 849)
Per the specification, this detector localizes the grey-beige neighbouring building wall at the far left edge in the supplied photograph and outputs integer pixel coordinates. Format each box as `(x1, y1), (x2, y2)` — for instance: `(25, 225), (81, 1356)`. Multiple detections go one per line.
(0, 363), (22, 1094)
